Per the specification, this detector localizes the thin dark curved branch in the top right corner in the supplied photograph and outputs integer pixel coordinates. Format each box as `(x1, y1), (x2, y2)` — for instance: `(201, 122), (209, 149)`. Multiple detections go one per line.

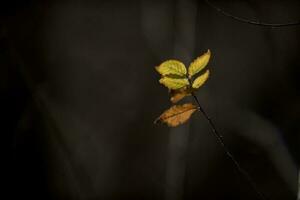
(205, 0), (300, 28)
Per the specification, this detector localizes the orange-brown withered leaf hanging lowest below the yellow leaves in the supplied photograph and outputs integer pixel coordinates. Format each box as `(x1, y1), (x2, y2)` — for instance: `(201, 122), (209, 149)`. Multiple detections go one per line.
(154, 103), (197, 127)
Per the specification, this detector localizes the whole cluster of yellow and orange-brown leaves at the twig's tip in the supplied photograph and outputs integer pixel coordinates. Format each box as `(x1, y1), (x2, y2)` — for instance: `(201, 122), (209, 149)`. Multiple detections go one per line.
(155, 50), (210, 127)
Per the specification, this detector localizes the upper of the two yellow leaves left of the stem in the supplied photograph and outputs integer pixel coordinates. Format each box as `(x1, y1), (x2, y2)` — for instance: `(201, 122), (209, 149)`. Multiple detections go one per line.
(155, 60), (187, 77)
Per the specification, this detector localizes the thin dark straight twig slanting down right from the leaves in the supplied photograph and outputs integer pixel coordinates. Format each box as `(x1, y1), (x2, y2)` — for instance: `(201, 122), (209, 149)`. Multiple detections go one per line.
(192, 93), (266, 200)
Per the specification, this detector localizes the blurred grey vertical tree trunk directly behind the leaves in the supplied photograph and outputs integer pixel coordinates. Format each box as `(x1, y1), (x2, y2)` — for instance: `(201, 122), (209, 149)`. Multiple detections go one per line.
(165, 0), (197, 200)
